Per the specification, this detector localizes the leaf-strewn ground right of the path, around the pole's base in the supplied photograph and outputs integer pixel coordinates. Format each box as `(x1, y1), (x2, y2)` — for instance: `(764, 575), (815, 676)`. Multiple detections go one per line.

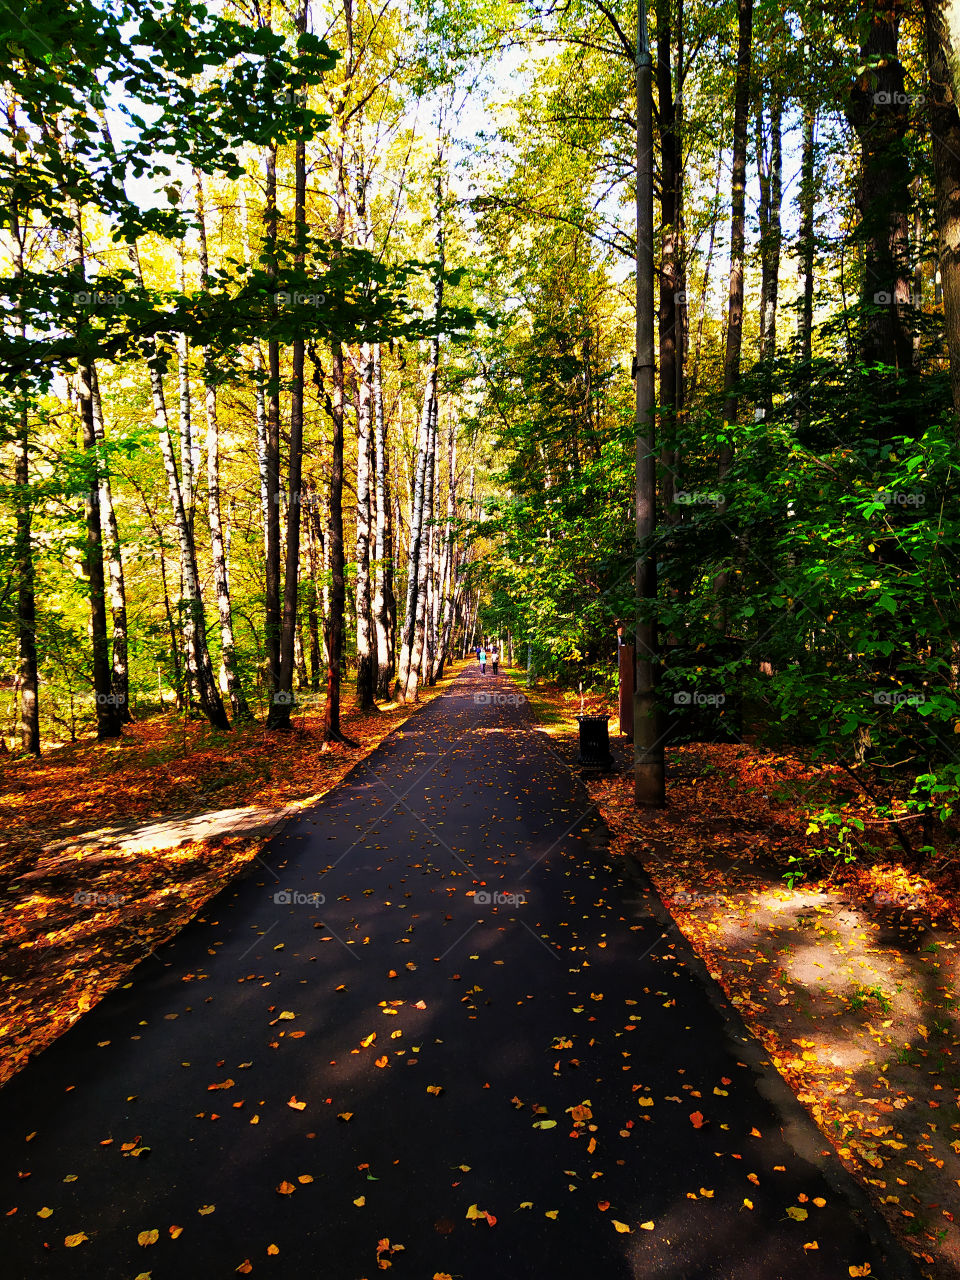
(525, 686), (960, 1277)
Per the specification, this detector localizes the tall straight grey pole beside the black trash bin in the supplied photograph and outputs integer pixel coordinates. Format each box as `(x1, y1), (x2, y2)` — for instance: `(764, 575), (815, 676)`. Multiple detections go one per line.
(634, 0), (664, 809)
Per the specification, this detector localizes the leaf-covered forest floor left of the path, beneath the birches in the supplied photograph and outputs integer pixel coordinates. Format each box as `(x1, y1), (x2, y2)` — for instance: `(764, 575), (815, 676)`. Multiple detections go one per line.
(0, 673), (453, 1084)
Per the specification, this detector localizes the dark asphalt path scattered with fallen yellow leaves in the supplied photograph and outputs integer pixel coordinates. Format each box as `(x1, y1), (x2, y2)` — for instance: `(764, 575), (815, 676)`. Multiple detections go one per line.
(0, 667), (906, 1280)
